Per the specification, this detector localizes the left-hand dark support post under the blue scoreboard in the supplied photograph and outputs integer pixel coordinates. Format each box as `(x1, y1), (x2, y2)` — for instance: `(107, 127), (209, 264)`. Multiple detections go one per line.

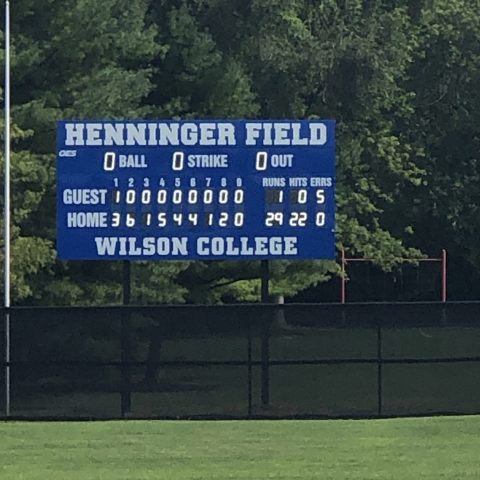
(121, 260), (132, 417)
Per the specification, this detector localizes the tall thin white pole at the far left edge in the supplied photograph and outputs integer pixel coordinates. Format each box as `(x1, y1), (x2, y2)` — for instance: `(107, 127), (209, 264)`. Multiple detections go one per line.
(4, 0), (10, 417)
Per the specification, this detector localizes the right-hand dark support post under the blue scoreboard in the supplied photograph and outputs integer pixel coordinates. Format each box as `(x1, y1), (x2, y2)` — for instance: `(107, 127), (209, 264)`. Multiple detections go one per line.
(260, 260), (272, 406)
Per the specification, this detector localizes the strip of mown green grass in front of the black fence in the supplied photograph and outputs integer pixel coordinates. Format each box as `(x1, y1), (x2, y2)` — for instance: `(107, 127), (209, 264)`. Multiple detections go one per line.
(0, 417), (480, 480)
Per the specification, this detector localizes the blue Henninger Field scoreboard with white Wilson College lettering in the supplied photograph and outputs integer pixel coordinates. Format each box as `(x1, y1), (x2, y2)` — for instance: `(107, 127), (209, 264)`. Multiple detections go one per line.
(57, 120), (335, 260)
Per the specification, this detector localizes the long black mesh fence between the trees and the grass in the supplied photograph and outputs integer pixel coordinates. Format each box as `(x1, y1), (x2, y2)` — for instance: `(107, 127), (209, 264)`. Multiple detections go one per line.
(0, 303), (480, 419)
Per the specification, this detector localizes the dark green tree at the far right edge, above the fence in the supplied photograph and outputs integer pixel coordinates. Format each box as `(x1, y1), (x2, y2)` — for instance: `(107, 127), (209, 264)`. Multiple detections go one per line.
(397, 0), (480, 298)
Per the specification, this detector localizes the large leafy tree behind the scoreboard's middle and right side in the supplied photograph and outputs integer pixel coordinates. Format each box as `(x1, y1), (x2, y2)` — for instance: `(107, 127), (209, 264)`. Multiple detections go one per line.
(142, 0), (423, 301)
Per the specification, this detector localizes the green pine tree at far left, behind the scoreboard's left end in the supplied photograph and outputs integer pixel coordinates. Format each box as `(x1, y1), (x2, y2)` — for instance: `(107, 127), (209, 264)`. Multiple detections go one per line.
(1, 0), (172, 304)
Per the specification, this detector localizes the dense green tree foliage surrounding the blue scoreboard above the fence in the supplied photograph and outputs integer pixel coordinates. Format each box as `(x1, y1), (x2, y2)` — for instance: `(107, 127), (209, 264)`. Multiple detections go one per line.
(2, 0), (480, 304)
